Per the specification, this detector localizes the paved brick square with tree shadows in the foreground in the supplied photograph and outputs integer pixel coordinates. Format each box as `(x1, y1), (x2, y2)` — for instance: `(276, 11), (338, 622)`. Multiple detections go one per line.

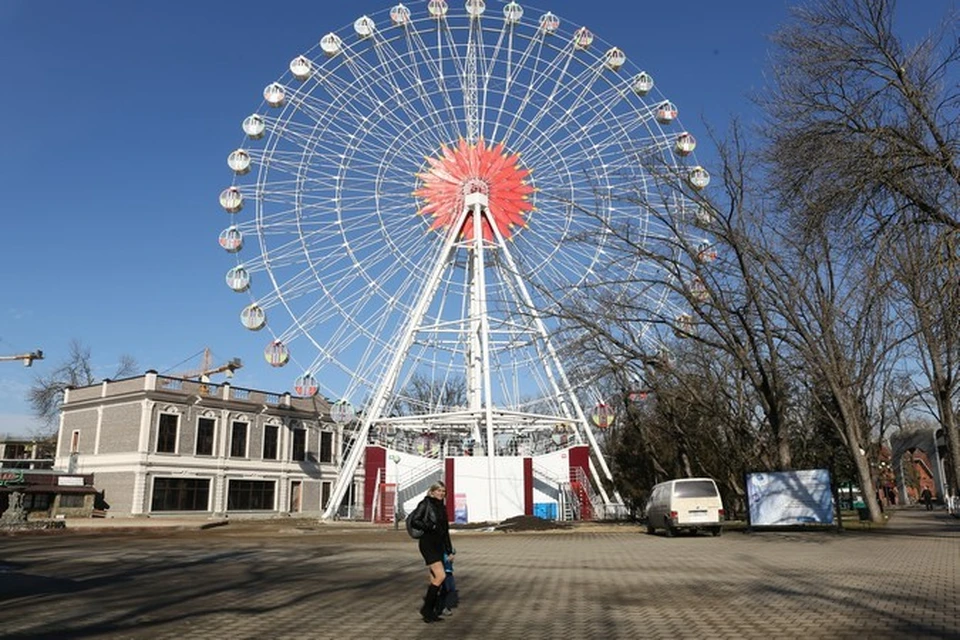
(0, 509), (960, 640)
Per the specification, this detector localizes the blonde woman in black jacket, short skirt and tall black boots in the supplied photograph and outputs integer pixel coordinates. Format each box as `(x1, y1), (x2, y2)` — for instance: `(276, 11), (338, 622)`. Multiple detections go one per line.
(410, 482), (453, 622)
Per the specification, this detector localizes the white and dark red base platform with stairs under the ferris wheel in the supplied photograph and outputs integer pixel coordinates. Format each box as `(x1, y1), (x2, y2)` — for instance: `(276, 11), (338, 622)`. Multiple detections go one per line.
(363, 444), (594, 524)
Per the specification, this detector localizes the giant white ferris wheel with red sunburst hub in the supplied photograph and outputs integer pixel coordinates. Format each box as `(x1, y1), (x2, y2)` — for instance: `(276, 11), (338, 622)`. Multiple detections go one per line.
(220, 0), (709, 517)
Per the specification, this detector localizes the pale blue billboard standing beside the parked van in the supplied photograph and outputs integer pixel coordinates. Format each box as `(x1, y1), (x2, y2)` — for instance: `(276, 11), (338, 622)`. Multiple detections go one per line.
(747, 469), (833, 527)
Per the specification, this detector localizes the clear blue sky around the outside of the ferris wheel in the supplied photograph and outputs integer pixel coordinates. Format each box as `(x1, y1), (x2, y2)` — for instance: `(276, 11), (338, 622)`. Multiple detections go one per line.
(0, 0), (948, 434)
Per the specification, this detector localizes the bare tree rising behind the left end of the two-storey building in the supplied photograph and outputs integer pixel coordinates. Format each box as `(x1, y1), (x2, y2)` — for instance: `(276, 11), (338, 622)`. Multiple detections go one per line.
(27, 340), (138, 428)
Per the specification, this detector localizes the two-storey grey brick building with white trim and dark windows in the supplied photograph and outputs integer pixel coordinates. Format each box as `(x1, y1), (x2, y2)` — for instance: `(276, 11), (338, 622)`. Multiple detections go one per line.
(55, 371), (359, 517)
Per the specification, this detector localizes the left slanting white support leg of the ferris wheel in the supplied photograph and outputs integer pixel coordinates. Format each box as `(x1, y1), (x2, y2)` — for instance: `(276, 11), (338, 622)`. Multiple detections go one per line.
(320, 209), (467, 520)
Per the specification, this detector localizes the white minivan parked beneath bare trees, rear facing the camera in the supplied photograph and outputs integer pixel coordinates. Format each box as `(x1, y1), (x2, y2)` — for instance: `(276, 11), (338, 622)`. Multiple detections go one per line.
(644, 478), (723, 537)
